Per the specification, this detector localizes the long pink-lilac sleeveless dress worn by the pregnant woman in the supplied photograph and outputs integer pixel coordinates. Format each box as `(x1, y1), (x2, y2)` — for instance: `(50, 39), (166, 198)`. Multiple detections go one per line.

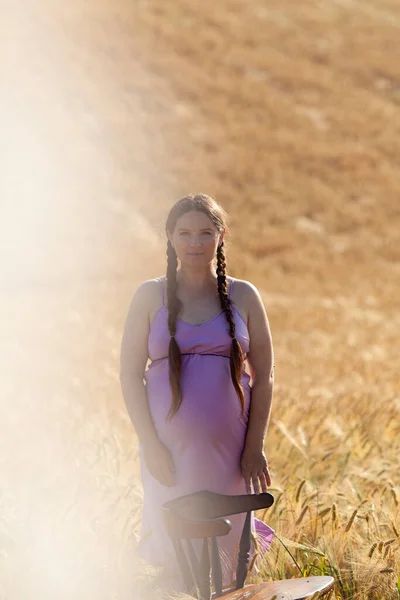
(139, 278), (274, 583)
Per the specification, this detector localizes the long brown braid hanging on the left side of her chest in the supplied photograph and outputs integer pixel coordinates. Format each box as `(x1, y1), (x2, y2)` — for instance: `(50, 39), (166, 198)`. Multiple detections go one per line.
(167, 240), (182, 419)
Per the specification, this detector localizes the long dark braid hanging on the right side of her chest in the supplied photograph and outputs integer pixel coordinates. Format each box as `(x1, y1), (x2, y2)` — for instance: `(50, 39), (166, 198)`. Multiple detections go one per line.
(217, 242), (245, 413)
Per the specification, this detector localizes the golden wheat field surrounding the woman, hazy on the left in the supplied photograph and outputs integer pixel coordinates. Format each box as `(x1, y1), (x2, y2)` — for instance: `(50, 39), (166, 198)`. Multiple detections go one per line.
(0, 0), (400, 600)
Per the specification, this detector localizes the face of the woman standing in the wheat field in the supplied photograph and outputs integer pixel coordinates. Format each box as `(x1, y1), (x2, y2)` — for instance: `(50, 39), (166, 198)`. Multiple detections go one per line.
(168, 210), (225, 267)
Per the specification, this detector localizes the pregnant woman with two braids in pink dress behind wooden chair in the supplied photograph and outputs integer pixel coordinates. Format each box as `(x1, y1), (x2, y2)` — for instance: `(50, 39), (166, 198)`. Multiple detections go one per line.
(120, 194), (274, 587)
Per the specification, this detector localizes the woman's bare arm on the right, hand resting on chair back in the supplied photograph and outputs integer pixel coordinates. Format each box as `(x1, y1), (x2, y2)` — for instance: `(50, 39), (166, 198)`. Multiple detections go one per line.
(242, 282), (274, 493)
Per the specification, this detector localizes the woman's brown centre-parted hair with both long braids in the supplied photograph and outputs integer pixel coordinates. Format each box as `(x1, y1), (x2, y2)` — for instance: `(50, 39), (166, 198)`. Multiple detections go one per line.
(165, 194), (244, 418)
